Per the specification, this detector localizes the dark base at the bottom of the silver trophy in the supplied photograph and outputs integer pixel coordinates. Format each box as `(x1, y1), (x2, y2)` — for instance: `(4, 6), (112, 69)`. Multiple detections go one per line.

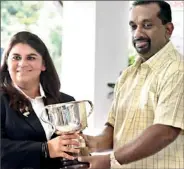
(60, 160), (89, 169)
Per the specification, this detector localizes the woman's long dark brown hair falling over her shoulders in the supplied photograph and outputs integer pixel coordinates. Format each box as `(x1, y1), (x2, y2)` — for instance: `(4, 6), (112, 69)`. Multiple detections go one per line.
(0, 31), (60, 110)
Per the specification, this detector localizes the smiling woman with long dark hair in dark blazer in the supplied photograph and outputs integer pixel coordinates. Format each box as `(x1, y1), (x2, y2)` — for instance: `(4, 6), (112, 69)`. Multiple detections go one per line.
(0, 31), (79, 169)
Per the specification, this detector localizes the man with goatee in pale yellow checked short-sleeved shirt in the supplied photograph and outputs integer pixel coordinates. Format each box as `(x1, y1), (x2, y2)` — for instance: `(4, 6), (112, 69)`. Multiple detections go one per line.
(79, 0), (184, 169)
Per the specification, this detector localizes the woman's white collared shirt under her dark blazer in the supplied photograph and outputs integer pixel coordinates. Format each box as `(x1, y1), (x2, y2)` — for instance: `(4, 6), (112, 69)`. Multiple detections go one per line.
(14, 84), (54, 140)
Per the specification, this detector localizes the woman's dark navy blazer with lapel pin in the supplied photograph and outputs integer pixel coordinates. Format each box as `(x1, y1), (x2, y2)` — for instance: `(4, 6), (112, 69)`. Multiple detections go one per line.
(0, 92), (74, 169)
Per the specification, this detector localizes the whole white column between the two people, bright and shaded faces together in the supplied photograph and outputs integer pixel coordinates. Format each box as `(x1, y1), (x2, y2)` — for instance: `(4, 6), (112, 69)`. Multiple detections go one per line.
(60, 1), (129, 129)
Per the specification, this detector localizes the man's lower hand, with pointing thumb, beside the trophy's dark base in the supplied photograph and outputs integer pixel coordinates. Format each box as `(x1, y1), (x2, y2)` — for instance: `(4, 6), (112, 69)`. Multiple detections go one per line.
(78, 155), (110, 169)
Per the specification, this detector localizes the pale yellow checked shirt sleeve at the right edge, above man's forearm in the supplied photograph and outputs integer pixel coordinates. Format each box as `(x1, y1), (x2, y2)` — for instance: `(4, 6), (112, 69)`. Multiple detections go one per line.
(154, 71), (184, 130)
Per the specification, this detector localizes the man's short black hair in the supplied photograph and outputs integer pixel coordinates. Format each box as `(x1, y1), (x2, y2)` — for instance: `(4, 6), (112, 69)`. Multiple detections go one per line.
(132, 0), (172, 25)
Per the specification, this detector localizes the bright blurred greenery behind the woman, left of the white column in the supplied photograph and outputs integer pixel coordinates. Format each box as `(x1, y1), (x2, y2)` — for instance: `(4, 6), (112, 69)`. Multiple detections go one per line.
(1, 1), (62, 73)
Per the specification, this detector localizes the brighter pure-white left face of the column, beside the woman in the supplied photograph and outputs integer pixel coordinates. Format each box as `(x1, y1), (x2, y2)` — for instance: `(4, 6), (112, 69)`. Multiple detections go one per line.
(60, 1), (95, 101)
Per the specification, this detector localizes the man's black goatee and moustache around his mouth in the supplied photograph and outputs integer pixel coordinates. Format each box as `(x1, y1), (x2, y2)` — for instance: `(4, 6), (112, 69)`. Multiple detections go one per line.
(133, 37), (151, 55)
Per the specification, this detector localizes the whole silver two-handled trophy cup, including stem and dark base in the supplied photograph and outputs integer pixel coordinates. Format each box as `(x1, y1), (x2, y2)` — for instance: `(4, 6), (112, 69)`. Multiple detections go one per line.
(41, 100), (93, 169)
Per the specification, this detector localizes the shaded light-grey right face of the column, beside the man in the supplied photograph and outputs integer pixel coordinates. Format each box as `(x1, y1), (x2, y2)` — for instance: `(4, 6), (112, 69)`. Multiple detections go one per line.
(94, 1), (129, 128)
